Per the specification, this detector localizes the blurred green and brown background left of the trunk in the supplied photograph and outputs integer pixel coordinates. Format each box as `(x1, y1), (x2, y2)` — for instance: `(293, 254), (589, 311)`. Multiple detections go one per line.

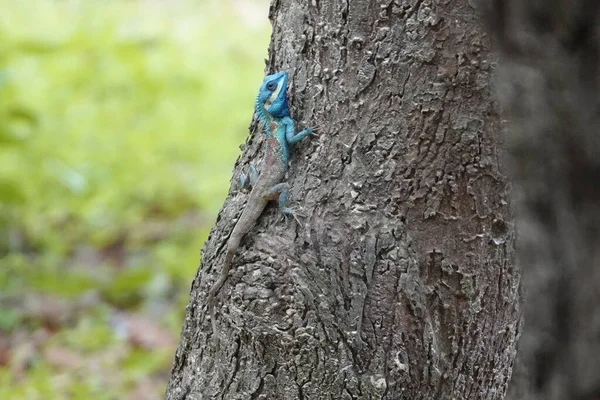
(0, 0), (270, 400)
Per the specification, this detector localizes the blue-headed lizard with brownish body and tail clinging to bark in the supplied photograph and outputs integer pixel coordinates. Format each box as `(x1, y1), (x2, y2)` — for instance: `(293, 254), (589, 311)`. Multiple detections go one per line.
(208, 72), (313, 351)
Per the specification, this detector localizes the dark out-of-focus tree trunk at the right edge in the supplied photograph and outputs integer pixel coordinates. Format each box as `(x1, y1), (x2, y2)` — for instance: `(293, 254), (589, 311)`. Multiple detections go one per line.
(488, 0), (600, 400)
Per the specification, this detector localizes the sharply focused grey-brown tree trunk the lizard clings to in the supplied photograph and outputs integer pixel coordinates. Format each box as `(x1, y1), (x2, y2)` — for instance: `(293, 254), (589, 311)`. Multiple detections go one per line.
(167, 0), (519, 400)
